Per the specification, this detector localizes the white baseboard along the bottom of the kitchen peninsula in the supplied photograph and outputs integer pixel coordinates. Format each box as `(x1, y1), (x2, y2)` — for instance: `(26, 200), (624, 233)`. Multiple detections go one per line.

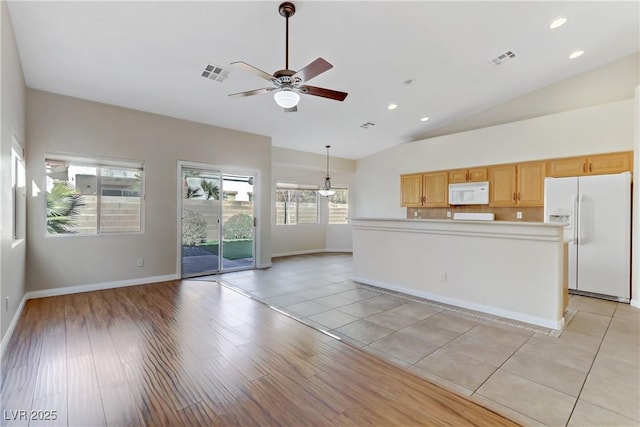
(353, 276), (564, 329)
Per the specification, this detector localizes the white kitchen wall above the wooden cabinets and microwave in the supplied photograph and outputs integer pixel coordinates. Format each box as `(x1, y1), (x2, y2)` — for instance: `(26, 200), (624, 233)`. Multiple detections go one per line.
(354, 99), (634, 218)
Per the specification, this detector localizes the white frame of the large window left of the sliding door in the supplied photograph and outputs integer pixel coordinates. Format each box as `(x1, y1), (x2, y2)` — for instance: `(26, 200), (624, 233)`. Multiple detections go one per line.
(43, 153), (146, 238)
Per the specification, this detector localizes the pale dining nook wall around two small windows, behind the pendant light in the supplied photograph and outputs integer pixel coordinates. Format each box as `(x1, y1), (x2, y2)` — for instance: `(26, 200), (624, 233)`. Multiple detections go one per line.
(271, 147), (357, 256)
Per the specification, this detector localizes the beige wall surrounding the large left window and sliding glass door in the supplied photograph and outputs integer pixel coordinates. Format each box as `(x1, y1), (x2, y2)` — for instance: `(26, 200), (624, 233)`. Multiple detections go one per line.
(27, 90), (271, 291)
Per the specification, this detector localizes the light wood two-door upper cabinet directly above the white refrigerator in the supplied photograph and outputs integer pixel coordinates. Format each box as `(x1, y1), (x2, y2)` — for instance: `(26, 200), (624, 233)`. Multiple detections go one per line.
(547, 151), (633, 177)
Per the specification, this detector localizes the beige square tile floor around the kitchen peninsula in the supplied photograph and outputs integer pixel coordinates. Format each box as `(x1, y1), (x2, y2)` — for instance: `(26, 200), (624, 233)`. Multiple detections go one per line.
(199, 254), (640, 426)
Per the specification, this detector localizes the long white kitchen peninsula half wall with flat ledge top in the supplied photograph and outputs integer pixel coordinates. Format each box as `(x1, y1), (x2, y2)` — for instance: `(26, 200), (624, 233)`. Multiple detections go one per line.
(352, 218), (566, 329)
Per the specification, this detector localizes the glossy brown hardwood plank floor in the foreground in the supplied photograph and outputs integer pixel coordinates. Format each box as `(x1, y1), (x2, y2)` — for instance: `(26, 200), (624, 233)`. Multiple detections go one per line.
(0, 280), (515, 426)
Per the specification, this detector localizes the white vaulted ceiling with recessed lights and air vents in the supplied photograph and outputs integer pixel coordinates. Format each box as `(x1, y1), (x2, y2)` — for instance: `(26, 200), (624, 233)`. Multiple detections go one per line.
(8, 0), (640, 159)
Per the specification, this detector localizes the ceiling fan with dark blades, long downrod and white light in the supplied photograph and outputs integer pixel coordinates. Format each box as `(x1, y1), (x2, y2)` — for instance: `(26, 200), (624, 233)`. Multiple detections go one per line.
(229, 2), (348, 113)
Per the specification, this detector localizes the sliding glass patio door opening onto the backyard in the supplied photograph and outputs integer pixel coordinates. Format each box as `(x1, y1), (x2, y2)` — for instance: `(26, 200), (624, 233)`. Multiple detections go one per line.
(181, 165), (255, 277)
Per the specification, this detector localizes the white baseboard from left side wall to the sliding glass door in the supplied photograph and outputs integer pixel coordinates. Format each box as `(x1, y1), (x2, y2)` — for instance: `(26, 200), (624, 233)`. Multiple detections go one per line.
(0, 274), (180, 358)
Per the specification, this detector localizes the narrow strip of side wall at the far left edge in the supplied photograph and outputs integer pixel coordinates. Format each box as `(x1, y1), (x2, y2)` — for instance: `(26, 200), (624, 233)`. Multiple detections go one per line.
(0, 1), (26, 348)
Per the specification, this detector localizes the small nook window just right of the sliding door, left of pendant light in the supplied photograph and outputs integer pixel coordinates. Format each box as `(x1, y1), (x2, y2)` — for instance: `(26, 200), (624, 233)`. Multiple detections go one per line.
(276, 183), (318, 225)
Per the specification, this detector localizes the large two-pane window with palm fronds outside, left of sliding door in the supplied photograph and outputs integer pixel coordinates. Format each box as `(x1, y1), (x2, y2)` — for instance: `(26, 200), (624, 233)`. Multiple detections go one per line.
(45, 155), (144, 235)
